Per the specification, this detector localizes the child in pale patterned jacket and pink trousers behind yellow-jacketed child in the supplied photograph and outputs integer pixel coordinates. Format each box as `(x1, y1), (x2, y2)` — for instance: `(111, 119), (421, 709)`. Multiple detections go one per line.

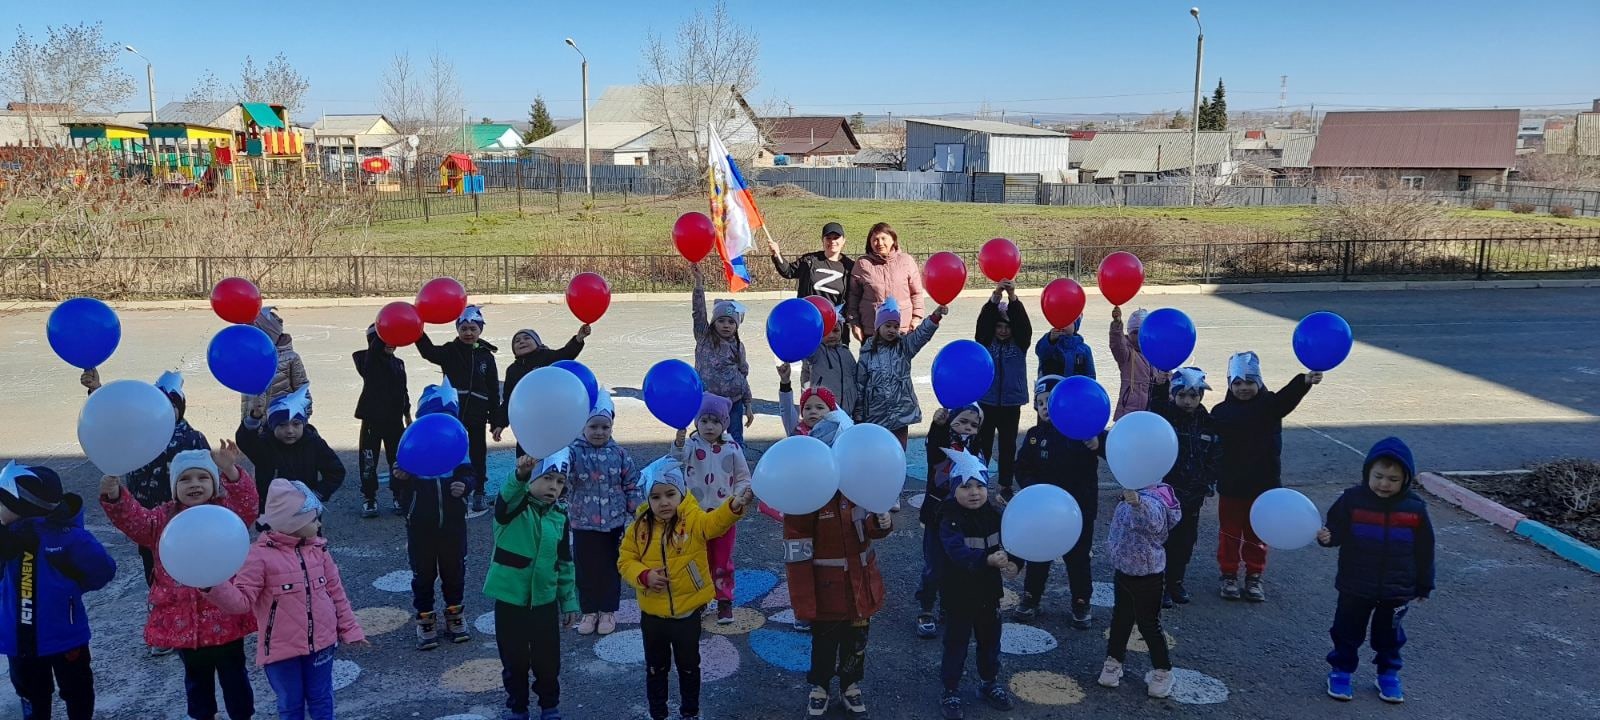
(672, 392), (750, 626)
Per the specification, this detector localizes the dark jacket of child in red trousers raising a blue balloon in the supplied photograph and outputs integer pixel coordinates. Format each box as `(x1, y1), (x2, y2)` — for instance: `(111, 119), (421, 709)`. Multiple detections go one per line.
(1211, 374), (1310, 499)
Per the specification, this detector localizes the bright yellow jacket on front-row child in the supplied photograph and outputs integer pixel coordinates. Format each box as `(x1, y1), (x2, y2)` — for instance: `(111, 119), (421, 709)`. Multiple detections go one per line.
(616, 493), (742, 618)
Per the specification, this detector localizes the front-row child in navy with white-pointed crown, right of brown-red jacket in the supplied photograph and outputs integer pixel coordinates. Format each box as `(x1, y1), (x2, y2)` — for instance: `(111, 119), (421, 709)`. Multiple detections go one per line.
(939, 448), (1022, 720)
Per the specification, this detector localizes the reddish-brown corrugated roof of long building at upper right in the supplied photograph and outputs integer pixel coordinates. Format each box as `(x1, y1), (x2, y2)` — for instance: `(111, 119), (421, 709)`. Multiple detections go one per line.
(1310, 110), (1520, 168)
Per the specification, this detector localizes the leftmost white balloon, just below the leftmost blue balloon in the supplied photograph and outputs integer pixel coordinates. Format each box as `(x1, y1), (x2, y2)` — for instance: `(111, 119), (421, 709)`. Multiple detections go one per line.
(78, 379), (178, 475)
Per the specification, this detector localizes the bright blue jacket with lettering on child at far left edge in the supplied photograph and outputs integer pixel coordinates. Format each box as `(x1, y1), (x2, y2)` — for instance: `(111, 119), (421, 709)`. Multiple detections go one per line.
(0, 493), (117, 658)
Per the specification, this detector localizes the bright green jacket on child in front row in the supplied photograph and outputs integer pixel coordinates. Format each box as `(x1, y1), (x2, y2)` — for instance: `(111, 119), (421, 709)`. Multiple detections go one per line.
(483, 472), (578, 613)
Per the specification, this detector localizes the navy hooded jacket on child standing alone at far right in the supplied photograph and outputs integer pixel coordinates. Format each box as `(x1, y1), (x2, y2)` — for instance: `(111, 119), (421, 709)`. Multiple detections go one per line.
(1328, 437), (1434, 600)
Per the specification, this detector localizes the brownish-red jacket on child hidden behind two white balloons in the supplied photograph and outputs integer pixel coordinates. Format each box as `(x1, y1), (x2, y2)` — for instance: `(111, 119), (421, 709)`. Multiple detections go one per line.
(784, 493), (890, 622)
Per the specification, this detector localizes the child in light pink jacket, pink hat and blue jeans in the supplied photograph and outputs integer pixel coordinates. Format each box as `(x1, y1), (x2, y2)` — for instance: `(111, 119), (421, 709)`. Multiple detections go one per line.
(202, 477), (370, 720)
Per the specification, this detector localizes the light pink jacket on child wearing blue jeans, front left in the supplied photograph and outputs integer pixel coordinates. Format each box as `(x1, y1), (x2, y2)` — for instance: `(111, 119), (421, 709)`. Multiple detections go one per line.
(206, 530), (366, 666)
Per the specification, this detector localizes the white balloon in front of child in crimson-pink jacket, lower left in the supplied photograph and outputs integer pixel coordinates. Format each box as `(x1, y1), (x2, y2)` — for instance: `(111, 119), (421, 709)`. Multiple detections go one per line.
(157, 506), (250, 587)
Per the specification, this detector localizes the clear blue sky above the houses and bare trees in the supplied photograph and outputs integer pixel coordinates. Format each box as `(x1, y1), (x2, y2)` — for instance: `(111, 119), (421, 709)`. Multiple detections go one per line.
(0, 0), (1600, 118)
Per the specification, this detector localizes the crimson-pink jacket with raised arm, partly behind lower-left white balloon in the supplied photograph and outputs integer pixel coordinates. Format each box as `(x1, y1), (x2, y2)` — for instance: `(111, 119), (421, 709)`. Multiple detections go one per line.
(101, 467), (256, 650)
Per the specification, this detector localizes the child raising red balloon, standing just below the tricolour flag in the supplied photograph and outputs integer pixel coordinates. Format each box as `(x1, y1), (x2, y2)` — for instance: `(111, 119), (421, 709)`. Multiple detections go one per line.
(690, 266), (755, 444)
